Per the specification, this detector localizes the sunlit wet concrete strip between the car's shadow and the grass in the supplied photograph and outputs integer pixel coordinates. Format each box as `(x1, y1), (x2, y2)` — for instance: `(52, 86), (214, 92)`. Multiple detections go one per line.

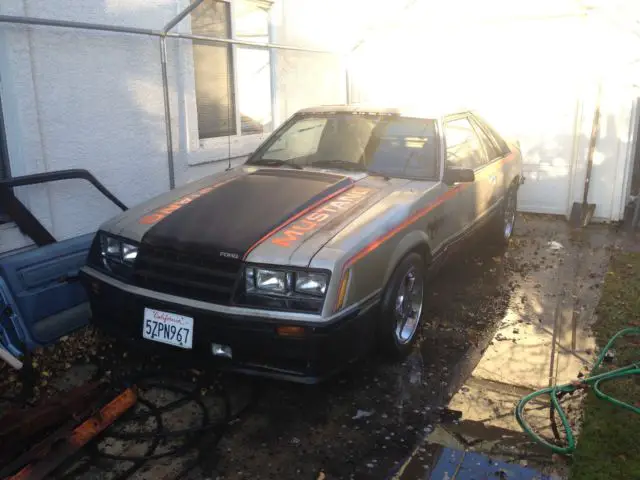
(402, 216), (619, 479)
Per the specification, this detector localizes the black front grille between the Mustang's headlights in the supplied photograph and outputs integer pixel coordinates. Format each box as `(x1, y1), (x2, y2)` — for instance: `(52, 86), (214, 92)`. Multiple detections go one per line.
(134, 245), (242, 305)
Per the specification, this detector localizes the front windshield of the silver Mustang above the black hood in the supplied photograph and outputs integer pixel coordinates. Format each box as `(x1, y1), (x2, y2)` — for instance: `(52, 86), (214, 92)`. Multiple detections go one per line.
(248, 113), (438, 179)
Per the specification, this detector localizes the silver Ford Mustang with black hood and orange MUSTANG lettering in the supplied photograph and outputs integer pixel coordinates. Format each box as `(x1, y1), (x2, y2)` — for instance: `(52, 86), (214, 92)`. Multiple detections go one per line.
(82, 106), (523, 382)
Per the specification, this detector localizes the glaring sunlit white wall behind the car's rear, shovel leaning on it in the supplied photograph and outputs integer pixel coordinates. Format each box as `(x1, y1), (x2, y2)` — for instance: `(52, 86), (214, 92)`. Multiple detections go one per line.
(350, 0), (640, 220)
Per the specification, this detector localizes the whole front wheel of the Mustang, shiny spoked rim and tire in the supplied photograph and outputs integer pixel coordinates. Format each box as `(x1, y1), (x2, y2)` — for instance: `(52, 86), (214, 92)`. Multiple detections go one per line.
(379, 252), (425, 359)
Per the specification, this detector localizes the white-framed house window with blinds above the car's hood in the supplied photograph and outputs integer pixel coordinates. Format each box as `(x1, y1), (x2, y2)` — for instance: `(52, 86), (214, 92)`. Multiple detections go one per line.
(191, 0), (272, 140)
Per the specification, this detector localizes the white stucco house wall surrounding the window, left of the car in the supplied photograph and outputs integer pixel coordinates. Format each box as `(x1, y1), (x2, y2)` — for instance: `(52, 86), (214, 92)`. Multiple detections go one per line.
(0, 0), (346, 253)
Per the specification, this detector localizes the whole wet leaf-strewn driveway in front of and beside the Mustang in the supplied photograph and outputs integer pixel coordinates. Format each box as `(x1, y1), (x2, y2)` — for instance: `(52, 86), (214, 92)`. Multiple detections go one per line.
(1, 216), (615, 480)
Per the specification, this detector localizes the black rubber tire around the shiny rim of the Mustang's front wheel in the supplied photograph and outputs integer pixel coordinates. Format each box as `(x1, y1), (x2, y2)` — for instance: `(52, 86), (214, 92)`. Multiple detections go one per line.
(378, 252), (425, 361)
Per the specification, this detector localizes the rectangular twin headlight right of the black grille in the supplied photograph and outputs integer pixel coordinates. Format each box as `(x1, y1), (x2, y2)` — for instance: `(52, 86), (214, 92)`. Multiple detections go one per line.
(245, 267), (329, 297)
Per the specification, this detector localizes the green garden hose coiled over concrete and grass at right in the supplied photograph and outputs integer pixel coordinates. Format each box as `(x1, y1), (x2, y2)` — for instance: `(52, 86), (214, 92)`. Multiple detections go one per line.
(516, 328), (640, 455)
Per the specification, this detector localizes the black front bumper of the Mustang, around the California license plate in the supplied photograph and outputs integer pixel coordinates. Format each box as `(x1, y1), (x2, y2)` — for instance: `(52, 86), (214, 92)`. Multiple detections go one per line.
(81, 268), (378, 383)
